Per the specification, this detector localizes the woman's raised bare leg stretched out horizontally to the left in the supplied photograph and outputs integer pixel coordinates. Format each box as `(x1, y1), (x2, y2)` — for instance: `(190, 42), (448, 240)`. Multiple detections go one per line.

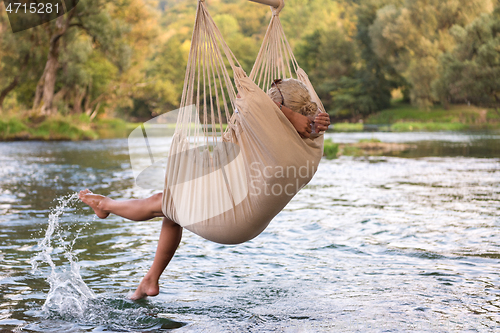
(78, 190), (165, 221)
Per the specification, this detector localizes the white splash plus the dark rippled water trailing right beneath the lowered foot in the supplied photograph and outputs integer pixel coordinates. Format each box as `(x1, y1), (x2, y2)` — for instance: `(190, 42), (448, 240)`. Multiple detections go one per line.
(31, 193), (185, 332)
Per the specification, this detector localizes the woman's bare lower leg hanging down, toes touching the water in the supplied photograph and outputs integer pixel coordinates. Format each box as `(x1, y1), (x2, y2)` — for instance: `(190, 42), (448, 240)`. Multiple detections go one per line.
(130, 217), (182, 300)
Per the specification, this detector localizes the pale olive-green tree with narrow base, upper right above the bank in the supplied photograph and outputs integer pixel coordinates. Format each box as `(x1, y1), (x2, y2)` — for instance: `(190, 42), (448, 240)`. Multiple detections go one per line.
(370, 0), (492, 108)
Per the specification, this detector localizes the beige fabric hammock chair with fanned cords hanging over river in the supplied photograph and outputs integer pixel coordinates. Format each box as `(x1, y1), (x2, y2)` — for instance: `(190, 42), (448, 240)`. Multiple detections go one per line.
(162, 0), (324, 244)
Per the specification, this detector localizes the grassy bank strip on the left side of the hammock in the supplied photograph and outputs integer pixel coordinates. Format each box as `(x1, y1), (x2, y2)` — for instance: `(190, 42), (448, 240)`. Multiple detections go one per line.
(0, 115), (129, 141)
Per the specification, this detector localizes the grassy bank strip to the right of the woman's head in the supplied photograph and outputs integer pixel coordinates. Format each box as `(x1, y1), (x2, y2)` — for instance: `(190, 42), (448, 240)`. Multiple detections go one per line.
(333, 103), (500, 132)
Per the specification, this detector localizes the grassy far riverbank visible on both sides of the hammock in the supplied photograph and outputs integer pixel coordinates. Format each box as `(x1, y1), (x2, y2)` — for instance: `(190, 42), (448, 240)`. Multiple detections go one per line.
(0, 103), (500, 141)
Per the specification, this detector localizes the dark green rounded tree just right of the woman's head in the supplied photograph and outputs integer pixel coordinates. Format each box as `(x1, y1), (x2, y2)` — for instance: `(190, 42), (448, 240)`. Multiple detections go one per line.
(296, 1), (404, 119)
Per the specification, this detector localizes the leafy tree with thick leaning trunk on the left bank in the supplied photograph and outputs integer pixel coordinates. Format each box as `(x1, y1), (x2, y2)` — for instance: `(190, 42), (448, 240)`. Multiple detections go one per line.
(28, 0), (156, 114)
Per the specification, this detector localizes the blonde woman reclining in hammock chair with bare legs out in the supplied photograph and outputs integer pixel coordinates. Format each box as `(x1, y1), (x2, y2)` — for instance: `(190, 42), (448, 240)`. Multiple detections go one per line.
(78, 79), (330, 300)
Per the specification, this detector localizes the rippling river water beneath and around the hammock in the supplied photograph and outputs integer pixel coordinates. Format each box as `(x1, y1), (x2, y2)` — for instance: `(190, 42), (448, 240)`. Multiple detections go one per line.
(0, 133), (500, 332)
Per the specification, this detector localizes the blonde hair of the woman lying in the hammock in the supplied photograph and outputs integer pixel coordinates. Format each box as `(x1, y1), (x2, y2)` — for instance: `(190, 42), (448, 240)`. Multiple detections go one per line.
(267, 79), (318, 117)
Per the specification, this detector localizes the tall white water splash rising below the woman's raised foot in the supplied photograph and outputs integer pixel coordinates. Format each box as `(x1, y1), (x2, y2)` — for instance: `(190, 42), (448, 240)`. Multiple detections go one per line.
(31, 193), (96, 318)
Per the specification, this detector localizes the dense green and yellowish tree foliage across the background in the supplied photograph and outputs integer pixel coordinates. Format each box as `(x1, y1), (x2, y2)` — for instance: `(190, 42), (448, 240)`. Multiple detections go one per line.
(0, 0), (500, 120)
